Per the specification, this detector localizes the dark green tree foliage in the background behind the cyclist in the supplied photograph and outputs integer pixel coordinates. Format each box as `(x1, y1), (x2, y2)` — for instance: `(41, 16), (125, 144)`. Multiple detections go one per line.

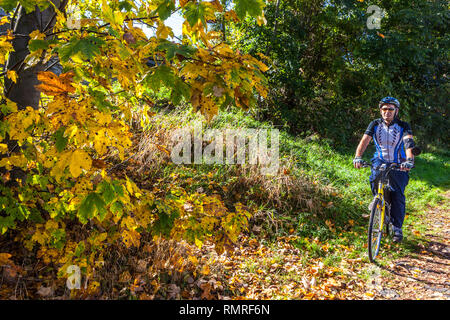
(232, 0), (450, 146)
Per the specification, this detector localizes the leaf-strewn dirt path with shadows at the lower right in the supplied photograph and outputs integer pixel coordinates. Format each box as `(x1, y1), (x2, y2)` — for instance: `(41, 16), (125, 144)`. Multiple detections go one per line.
(368, 191), (450, 300)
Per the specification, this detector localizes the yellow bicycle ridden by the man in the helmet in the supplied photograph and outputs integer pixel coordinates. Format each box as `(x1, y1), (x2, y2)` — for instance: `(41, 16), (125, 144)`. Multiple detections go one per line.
(362, 162), (406, 262)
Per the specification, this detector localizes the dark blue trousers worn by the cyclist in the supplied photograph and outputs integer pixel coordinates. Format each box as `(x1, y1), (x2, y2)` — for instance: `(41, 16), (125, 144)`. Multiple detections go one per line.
(369, 159), (409, 231)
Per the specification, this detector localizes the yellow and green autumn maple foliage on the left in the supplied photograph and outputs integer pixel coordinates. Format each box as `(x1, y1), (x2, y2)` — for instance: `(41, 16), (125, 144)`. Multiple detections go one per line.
(0, 0), (266, 288)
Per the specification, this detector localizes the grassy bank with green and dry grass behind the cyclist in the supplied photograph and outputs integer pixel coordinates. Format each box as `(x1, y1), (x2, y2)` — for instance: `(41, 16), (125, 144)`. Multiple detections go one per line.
(134, 104), (450, 264)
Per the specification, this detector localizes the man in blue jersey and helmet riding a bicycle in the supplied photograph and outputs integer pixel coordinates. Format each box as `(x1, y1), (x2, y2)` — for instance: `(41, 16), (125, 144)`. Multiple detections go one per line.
(353, 97), (415, 242)
